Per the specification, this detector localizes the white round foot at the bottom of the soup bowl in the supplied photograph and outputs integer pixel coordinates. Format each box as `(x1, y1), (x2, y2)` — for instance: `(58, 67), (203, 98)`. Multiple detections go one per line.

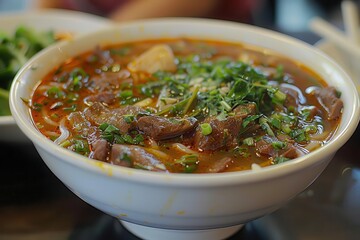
(120, 220), (244, 240)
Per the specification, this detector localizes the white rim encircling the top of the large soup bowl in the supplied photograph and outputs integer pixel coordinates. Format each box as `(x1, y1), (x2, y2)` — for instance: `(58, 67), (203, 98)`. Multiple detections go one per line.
(10, 17), (360, 187)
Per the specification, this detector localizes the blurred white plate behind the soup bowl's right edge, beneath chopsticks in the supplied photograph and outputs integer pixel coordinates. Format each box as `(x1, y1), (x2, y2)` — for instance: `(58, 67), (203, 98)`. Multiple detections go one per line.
(315, 40), (360, 92)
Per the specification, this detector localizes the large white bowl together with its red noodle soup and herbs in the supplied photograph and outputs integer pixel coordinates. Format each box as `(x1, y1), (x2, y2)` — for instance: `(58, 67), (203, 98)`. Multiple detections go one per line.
(10, 18), (359, 239)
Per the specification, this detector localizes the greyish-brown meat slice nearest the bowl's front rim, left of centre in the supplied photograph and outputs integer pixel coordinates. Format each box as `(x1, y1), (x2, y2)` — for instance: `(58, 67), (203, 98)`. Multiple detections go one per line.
(109, 144), (167, 172)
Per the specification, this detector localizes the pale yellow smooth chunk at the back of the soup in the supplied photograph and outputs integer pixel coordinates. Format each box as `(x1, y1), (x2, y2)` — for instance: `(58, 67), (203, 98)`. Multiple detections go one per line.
(128, 44), (176, 73)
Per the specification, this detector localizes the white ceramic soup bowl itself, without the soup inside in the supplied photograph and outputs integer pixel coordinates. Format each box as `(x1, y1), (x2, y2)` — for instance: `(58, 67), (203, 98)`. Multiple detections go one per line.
(10, 19), (359, 240)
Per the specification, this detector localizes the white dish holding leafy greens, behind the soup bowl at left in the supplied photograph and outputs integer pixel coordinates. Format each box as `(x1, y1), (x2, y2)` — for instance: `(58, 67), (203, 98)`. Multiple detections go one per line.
(0, 9), (111, 143)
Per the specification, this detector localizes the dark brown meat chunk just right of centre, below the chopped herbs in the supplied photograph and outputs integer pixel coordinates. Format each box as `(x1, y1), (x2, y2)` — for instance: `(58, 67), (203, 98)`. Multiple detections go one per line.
(194, 115), (243, 151)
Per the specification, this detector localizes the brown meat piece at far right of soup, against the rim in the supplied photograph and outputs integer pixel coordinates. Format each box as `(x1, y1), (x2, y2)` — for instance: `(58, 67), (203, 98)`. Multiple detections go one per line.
(315, 87), (343, 120)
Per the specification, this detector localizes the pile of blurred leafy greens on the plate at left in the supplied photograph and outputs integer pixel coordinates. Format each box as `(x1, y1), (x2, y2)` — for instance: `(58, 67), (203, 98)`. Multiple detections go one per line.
(0, 26), (55, 116)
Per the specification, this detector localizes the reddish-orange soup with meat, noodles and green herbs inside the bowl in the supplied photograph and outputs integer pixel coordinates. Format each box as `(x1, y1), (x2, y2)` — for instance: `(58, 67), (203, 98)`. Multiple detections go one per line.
(30, 38), (343, 173)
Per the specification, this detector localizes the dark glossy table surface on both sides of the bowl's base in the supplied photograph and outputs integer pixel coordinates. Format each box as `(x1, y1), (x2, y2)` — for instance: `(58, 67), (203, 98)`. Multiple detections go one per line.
(0, 30), (360, 240)
